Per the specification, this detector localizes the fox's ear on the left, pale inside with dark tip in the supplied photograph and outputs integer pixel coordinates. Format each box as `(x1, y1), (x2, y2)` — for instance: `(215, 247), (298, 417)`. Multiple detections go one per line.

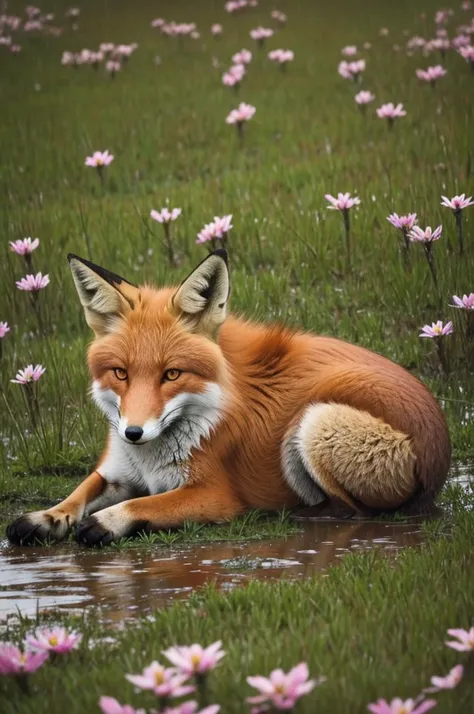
(67, 253), (139, 337)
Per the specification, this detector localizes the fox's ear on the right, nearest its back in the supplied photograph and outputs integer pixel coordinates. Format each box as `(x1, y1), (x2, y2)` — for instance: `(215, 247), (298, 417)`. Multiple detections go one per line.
(170, 250), (230, 337)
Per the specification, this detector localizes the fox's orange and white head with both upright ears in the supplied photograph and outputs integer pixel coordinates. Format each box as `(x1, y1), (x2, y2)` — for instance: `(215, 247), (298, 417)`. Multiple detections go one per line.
(68, 250), (229, 445)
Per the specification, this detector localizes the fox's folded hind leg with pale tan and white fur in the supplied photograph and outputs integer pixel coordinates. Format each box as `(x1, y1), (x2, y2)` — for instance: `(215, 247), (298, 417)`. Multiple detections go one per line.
(283, 403), (416, 514)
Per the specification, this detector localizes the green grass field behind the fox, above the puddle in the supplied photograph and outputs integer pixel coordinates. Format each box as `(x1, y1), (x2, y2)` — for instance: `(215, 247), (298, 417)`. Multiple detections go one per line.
(0, 0), (474, 484)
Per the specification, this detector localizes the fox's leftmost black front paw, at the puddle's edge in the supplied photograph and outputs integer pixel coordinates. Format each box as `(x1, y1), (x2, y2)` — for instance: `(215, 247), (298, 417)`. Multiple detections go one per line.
(7, 510), (72, 545)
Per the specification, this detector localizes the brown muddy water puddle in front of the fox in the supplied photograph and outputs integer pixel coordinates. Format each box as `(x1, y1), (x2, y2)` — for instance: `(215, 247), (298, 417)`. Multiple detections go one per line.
(0, 468), (474, 622)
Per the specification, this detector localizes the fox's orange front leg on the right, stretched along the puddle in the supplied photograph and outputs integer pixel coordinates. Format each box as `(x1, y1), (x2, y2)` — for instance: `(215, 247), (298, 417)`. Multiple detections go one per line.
(77, 485), (245, 546)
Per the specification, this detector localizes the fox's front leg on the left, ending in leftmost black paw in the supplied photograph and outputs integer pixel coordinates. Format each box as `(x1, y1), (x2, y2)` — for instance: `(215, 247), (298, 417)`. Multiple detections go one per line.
(7, 471), (137, 545)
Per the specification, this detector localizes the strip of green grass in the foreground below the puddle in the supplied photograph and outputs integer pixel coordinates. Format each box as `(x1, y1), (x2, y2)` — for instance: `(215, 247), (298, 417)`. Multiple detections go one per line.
(3, 489), (474, 714)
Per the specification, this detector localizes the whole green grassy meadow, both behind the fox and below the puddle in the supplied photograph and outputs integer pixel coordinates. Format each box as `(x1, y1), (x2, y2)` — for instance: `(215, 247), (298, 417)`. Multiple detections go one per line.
(0, 0), (474, 714)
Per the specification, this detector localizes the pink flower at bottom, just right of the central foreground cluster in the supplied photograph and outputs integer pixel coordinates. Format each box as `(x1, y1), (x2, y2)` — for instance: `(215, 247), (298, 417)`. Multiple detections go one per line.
(247, 662), (323, 709)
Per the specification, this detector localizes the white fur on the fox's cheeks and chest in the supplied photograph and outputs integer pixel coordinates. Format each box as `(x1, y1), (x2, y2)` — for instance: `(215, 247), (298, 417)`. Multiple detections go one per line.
(92, 383), (226, 494)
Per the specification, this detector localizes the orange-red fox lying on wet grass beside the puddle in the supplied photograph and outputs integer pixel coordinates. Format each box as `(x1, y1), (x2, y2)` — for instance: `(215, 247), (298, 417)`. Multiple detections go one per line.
(7, 249), (451, 546)
